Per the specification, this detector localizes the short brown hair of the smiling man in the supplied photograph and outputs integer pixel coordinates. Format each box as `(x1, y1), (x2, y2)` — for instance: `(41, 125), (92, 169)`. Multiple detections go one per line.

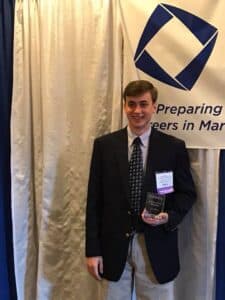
(123, 80), (158, 103)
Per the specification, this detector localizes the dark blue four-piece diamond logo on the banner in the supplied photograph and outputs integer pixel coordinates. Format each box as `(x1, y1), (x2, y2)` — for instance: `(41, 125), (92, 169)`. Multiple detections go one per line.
(134, 4), (218, 90)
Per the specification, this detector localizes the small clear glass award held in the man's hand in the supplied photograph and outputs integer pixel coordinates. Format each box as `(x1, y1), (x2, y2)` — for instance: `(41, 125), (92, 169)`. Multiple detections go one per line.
(145, 192), (165, 218)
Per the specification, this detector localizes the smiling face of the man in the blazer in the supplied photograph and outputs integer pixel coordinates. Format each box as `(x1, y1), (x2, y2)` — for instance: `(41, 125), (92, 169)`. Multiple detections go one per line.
(124, 92), (156, 135)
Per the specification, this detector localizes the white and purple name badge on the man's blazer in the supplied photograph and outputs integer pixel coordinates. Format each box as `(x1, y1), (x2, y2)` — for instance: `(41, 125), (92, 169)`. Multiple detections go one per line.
(155, 171), (174, 195)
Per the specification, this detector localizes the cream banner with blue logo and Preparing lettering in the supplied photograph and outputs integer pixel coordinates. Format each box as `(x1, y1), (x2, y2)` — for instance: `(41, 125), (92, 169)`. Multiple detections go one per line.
(120, 0), (225, 149)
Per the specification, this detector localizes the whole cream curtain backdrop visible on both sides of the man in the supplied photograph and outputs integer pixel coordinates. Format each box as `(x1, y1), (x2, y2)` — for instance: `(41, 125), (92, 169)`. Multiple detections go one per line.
(11, 0), (219, 300)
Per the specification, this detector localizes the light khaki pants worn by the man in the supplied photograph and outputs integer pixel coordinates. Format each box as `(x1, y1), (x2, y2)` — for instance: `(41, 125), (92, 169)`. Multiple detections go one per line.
(102, 234), (174, 300)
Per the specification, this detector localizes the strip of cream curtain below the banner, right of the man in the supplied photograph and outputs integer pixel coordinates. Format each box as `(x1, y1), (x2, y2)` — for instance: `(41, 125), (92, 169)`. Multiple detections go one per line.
(175, 150), (219, 300)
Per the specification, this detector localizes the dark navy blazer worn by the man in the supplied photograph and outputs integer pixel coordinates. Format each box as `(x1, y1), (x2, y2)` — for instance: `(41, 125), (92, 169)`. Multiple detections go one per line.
(86, 128), (196, 283)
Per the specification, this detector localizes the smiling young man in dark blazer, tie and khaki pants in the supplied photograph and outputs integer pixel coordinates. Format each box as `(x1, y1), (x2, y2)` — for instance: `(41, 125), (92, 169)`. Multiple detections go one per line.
(86, 80), (196, 300)
